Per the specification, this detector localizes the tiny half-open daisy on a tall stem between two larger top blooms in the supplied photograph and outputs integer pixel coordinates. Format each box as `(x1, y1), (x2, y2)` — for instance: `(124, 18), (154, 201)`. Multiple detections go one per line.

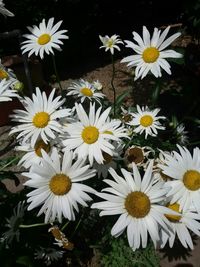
(99, 34), (123, 55)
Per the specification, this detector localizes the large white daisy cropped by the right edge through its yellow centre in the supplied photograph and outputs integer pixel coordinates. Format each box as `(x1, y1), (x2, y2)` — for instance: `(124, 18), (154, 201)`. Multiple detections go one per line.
(158, 145), (200, 214)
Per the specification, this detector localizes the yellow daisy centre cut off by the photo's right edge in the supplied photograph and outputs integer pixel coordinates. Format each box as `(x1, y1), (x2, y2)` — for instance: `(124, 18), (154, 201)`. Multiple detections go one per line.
(183, 170), (200, 191)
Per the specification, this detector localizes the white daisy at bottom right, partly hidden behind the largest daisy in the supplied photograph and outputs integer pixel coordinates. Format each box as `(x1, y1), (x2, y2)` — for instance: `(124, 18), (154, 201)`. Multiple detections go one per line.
(160, 203), (200, 249)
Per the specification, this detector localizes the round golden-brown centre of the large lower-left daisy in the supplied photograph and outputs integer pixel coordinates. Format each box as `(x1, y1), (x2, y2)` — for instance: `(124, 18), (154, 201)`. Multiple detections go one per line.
(49, 173), (72, 196)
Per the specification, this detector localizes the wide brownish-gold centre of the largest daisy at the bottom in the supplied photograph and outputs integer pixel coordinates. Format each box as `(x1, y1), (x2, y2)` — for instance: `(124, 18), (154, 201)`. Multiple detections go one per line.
(125, 191), (151, 218)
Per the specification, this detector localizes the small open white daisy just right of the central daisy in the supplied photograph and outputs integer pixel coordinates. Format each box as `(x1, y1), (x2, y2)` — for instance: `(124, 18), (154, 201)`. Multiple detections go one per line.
(128, 105), (166, 139)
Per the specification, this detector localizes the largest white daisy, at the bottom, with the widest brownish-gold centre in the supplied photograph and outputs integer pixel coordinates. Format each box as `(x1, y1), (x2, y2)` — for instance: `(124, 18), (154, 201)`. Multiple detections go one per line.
(92, 161), (177, 250)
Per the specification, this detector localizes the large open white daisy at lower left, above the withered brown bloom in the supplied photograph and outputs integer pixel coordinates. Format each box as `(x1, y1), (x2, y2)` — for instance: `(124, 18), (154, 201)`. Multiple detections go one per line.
(23, 150), (96, 222)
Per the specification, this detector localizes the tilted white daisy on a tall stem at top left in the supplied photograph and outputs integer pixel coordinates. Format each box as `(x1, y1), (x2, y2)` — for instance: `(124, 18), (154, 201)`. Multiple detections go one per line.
(21, 18), (69, 59)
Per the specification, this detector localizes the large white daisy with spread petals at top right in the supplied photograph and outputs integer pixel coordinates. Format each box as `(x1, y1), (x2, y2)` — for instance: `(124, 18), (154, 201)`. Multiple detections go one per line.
(121, 26), (182, 80)
